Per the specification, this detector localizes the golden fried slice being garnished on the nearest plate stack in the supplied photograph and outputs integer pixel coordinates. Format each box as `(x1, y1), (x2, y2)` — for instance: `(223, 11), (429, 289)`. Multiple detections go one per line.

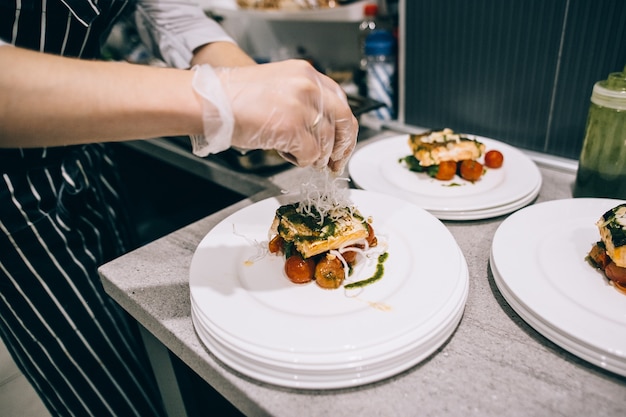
(270, 204), (369, 259)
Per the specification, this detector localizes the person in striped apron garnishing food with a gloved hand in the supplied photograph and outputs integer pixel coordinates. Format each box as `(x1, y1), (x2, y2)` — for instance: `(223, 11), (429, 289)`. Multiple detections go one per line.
(0, 0), (358, 416)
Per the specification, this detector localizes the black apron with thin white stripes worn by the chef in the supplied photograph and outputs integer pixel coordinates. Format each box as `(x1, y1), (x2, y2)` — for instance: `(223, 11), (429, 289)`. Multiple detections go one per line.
(0, 0), (164, 417)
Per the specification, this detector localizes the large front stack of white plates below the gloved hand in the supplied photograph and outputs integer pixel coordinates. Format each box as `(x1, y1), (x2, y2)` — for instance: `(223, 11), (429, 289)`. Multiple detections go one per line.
(190, 190), (468, 389)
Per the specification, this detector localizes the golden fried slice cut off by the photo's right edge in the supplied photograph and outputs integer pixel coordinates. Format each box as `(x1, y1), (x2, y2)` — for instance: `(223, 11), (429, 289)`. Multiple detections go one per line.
(596, 204), (626, 268)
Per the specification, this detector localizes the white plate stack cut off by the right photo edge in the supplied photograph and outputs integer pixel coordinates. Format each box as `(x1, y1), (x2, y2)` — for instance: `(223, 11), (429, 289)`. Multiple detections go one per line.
(491, 198), (626, 376)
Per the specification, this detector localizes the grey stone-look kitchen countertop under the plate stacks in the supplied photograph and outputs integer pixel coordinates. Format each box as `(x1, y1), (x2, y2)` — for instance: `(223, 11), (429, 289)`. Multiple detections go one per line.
(100, 132), (626, 417)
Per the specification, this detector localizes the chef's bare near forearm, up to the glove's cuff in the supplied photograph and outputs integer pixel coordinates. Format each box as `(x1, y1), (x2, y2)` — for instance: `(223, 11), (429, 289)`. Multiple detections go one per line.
(0, 45), (203, 147)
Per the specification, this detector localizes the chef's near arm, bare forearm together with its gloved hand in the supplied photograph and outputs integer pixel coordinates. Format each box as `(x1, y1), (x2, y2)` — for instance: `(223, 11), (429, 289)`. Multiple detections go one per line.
(0, 45), (358, 172)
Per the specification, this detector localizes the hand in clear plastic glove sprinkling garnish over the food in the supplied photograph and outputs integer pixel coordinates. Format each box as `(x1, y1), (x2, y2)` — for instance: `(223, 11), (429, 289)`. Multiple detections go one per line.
(192, 60), (358, 173)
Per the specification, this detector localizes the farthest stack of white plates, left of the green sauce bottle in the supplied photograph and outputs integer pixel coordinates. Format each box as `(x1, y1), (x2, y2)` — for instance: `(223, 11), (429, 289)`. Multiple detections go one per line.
(349, 135), (542, 220)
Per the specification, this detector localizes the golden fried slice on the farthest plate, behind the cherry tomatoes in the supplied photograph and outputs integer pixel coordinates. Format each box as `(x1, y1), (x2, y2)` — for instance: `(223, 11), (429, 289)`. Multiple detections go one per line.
(409, 129), (485, 167)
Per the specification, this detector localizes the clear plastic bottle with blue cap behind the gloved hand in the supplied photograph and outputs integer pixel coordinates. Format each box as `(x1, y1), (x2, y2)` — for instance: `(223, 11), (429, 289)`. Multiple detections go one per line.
(365, 30), (396, 120)
